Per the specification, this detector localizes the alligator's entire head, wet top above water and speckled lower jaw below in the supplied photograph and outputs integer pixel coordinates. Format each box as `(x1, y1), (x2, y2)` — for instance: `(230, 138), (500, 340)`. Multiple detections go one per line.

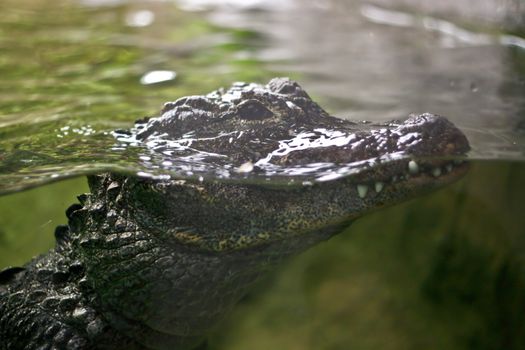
(108, 78), (469, 251)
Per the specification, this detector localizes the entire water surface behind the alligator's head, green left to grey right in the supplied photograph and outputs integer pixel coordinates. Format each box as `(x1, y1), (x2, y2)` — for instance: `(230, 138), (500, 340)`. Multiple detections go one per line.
(0, 0), (525, 191)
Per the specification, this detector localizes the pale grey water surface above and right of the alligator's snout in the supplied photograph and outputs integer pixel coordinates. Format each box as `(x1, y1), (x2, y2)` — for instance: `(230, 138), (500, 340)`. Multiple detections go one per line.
(196, 1), (525, 159)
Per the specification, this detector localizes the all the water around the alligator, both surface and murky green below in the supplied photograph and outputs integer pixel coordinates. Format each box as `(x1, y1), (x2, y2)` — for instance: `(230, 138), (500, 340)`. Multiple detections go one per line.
(0, 0), (525, 349)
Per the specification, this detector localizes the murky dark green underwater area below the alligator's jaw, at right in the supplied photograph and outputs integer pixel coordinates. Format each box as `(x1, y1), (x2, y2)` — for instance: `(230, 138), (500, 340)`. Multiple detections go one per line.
(209, 162), (525, 349)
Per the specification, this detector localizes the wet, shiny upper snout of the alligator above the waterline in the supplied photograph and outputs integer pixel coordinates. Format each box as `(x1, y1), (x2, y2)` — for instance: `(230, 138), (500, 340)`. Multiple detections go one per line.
(268, 113), (470, 166)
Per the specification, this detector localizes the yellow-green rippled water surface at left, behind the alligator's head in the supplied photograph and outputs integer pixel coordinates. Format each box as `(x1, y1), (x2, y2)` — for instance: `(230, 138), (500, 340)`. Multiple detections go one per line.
(0, 0), (273, 192)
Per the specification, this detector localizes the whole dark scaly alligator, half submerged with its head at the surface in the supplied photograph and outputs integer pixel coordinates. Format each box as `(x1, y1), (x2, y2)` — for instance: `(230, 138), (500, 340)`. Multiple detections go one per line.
(0, 78), (469, 350)
